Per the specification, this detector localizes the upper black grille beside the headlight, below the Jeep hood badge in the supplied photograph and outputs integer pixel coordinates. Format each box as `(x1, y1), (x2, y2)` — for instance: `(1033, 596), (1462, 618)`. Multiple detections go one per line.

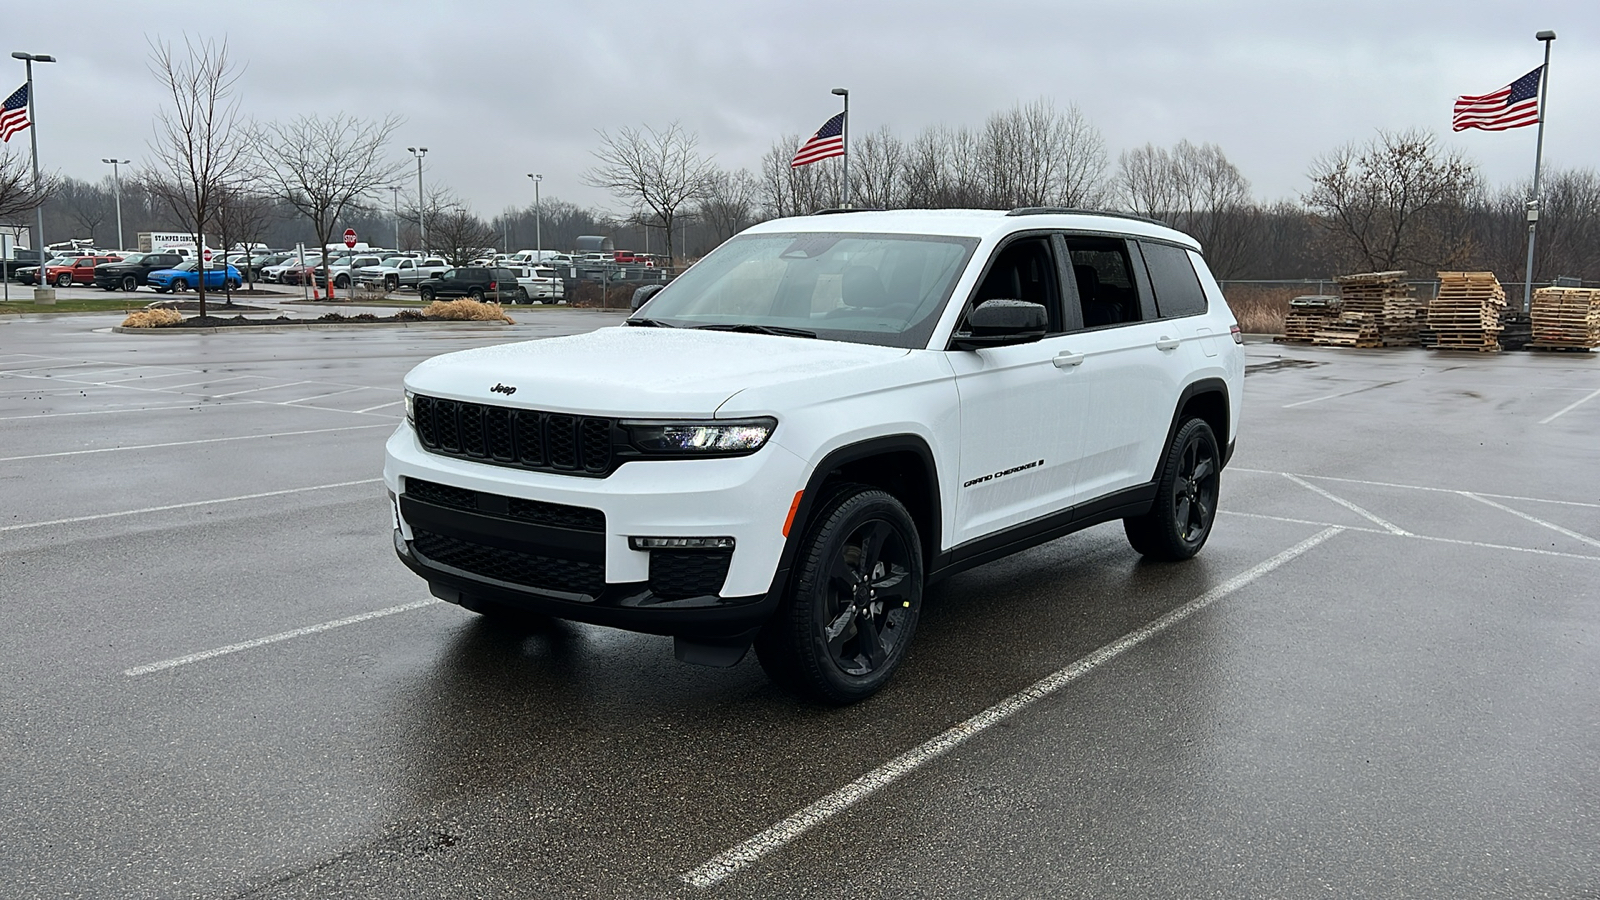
(411, 394), (626, 477)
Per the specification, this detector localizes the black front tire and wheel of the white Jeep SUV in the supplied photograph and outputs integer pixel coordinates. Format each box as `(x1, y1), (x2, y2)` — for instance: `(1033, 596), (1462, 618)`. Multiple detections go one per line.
(755, 485), (923, 705)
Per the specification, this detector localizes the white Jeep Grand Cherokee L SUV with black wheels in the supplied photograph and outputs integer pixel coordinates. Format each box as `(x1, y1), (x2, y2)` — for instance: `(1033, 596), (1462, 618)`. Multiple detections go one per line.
(384, 208), (1245, 703)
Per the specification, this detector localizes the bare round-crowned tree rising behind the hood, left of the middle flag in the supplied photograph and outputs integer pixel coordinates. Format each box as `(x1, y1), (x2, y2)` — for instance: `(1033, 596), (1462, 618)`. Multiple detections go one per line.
(584, 122), (710, 261)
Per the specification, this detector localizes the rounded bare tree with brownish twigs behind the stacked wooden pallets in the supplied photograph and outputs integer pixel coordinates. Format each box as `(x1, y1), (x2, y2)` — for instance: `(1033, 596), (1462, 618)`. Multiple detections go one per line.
(1304, 130), (1478, 271)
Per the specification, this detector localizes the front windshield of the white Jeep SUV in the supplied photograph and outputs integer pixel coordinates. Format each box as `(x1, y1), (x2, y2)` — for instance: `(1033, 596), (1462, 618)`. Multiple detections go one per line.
(642, 234), (978, 348)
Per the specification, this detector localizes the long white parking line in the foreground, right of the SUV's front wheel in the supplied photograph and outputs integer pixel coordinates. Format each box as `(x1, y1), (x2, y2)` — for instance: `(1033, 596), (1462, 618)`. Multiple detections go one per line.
(678, 525), (1344, 889)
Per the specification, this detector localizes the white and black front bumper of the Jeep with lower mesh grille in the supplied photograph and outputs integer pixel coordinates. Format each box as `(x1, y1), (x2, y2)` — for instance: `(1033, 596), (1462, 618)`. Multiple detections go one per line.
(384, 424), (805, 639)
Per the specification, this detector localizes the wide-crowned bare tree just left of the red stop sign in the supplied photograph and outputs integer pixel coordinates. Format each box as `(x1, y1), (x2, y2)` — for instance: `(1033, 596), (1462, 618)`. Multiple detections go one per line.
(256, 114), (403, 286)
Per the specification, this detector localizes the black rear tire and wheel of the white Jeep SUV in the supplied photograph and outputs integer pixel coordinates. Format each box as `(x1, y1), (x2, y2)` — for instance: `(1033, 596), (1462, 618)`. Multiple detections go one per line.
(1122, 418), (1222, 562)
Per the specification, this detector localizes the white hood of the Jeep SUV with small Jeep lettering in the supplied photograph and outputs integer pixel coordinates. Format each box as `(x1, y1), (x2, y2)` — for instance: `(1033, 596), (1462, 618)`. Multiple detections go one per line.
(405, 327), (910, 418)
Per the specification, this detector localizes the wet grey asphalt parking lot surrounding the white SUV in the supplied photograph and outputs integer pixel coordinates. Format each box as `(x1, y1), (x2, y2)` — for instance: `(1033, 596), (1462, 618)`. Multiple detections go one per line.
(0, 302), (1600, 898)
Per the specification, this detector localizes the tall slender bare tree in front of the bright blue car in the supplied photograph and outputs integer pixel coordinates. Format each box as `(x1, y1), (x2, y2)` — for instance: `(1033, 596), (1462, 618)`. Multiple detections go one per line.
(138, 37), (250, 315)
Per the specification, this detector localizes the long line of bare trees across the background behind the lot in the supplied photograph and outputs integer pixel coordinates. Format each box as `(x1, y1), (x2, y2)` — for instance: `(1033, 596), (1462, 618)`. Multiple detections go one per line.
(0, 42), (1600, 282)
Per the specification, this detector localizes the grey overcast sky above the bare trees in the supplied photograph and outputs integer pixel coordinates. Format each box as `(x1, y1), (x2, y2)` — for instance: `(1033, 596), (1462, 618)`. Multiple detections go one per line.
(0, 0), (1600, 216)
